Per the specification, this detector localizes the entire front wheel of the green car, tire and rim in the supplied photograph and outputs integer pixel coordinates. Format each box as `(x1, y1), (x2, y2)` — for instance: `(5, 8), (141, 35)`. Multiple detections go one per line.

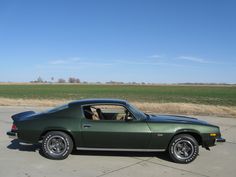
(169, 134), (199, 164)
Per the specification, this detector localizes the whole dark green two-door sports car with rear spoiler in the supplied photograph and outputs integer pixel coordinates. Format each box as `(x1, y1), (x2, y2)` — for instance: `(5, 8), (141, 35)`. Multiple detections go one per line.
(7, 99), (225, 163)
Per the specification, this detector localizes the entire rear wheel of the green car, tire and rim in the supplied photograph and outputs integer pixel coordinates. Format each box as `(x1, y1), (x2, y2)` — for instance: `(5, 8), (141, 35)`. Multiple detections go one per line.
(42, 131), (73, 160)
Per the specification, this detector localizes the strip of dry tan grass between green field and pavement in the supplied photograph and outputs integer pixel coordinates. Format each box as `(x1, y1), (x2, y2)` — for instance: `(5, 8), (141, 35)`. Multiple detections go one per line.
(0, 98), (236, 117)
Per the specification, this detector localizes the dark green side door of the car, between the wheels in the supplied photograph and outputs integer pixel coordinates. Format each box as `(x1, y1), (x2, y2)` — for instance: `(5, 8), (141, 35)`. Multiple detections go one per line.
(81, 106), (151, 149)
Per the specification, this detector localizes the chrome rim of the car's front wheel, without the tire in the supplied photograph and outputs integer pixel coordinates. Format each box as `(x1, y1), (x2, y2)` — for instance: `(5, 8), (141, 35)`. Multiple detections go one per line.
(174, 140), (194, 160)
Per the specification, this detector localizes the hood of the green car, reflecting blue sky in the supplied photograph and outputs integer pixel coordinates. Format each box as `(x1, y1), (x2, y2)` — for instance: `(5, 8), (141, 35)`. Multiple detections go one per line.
(147, 115), (210, 125)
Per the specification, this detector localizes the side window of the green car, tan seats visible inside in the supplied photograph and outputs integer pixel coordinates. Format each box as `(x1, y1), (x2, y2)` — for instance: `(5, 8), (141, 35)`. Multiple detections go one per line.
(83, 104), (133, 121)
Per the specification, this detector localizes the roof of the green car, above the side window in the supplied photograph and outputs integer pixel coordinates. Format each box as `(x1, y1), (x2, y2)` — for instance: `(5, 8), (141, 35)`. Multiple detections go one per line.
(69, 98), (127, 105)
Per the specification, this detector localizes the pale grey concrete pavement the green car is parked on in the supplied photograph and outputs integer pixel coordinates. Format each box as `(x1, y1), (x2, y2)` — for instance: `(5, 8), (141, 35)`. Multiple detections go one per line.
(0, 107), (236, 177)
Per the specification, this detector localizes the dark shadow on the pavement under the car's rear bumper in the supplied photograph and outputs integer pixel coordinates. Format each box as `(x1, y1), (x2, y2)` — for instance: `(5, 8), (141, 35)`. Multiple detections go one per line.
(7, 139), (40, 152)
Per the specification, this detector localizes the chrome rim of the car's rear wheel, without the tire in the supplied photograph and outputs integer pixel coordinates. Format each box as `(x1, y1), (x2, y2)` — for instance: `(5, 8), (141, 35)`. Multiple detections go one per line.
(47, 135), (67, 155)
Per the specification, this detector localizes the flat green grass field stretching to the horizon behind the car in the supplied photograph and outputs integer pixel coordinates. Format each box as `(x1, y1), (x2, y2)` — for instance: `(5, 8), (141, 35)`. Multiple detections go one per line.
(0, 84), (236, 106)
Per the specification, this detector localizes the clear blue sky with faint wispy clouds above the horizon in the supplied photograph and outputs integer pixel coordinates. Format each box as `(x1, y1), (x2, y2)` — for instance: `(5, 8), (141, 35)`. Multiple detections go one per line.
(0, 0), (236, 83)
